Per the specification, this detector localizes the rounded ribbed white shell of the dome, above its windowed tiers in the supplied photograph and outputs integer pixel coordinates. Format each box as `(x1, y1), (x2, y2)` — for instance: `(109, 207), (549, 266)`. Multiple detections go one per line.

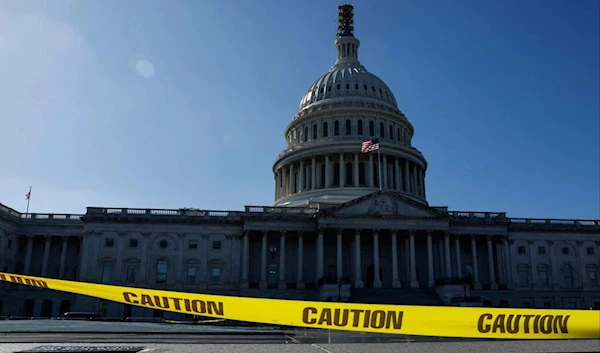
(298, 61), (398, 111)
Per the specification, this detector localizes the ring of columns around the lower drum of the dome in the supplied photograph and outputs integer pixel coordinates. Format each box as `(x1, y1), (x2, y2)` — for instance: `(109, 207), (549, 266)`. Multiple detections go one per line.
(275, 152), (425, 199)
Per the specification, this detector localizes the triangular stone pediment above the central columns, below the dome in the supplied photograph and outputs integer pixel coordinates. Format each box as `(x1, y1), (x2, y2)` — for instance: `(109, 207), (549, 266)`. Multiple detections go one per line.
(323, 191), (447, 218)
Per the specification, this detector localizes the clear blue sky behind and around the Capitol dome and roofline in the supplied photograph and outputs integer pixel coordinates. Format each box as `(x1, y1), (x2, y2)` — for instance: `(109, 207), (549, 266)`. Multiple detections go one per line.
(0, 0), (600, 219)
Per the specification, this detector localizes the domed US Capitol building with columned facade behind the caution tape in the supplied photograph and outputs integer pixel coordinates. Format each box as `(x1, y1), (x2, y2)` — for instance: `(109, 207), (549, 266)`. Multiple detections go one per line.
(0, 5), (600, 318)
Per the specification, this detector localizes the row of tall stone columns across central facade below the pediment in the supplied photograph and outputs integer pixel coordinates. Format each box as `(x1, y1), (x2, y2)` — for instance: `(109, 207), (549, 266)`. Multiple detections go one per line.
(242, 229), (502, 290)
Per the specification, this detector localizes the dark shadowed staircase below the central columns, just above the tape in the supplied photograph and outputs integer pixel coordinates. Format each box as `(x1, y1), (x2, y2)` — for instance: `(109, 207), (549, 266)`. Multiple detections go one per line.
(351, 288), (445, 306)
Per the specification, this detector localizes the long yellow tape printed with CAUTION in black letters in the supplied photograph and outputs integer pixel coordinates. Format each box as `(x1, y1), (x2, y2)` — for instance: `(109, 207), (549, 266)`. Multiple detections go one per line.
(0, 272), (600, 339)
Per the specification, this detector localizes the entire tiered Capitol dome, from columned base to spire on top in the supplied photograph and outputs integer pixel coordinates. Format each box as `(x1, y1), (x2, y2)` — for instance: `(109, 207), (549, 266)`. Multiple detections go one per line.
(273, 5), (427, 207)
